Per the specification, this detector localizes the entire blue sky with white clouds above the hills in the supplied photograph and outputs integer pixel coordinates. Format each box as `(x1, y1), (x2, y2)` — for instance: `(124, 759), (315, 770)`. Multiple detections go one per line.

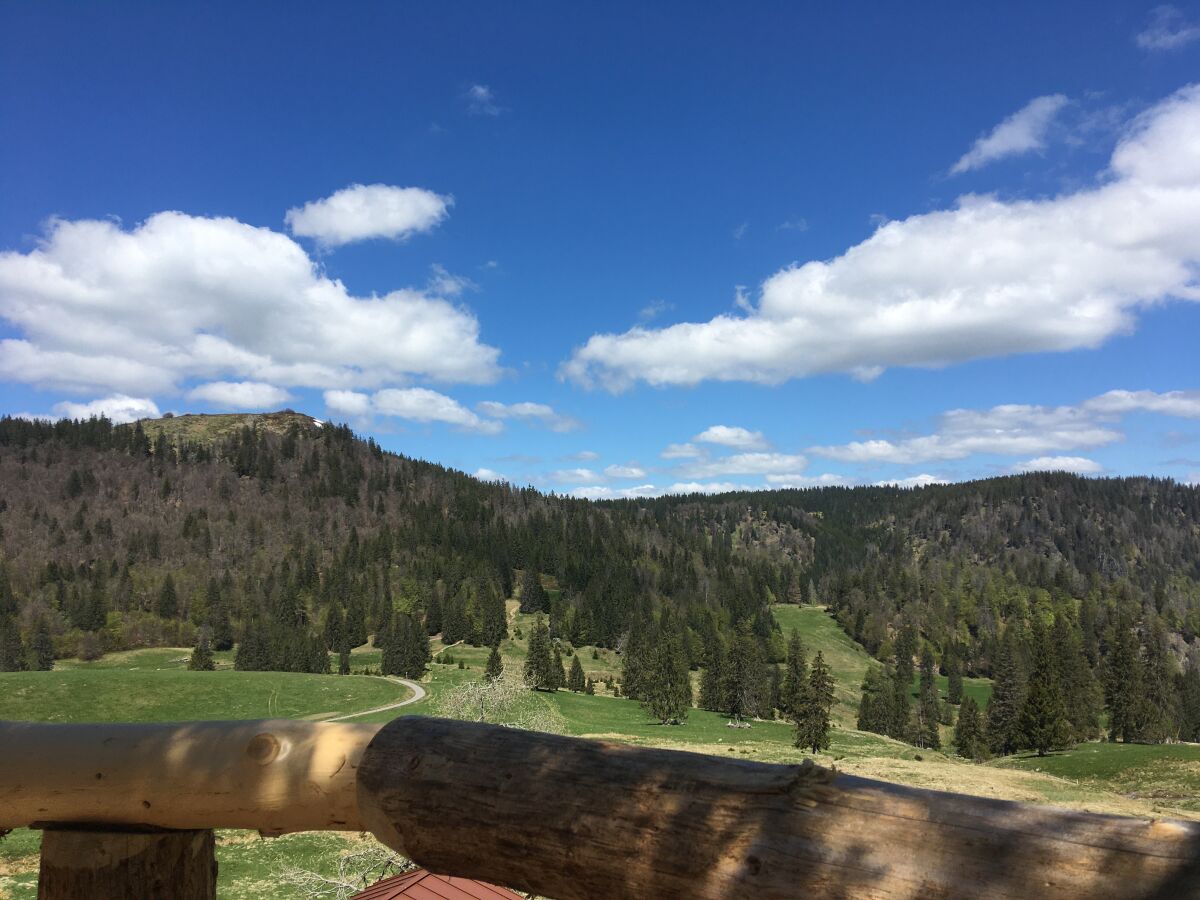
(0, 2), (1200, 496)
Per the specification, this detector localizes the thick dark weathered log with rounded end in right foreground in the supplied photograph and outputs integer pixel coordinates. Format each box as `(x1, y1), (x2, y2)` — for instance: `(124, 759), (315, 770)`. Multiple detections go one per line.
(359, 718), (1200, 900)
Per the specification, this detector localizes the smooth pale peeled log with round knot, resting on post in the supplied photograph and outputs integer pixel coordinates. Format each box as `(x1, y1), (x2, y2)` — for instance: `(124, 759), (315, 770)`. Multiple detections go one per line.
(0, 719), (379, 834)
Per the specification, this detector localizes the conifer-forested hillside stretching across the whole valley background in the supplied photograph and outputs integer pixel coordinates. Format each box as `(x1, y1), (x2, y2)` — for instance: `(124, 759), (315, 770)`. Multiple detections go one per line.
(0, 413), (1200, 752)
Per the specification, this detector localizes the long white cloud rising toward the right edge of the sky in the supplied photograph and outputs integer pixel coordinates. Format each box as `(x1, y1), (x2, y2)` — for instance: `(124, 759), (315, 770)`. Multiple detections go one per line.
(560, 85), (1200, 390)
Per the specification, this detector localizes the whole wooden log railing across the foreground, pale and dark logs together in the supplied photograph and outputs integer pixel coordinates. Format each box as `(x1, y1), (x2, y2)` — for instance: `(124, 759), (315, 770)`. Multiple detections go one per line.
(0, 718), (1200, 900)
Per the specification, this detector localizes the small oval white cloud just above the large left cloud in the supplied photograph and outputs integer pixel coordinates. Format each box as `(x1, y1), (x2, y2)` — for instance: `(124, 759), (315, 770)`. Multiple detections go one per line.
(283, 185), (454, 247)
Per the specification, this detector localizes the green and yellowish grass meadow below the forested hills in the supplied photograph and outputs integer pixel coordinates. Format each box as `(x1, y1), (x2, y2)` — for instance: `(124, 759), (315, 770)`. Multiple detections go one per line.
(0, 602), (1200, 900)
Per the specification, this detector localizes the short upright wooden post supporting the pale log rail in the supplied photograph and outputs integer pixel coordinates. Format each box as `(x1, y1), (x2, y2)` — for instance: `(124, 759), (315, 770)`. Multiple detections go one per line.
(37, 828), (217, 900)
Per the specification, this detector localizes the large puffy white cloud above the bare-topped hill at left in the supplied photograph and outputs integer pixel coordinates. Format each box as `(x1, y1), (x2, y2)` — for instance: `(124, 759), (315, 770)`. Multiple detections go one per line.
(0, 212), (500, 395)
